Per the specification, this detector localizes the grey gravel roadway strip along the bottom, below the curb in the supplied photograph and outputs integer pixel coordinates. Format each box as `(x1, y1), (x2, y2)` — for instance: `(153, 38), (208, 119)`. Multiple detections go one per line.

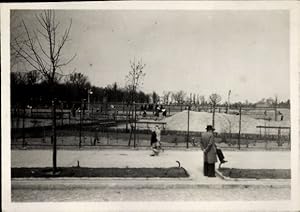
(12, 187), (290, 202)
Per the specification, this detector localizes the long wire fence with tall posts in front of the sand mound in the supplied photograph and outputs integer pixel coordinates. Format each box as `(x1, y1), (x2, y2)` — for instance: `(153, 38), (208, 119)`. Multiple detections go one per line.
(11, 101), (290, 150)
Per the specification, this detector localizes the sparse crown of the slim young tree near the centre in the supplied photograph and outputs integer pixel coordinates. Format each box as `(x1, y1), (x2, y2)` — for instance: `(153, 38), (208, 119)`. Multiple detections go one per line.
(126, 59), (146, 103)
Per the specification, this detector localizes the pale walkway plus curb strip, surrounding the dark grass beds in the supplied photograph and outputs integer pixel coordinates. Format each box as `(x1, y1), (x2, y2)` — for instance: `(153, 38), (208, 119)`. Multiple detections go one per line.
(11, 149), (290, 187)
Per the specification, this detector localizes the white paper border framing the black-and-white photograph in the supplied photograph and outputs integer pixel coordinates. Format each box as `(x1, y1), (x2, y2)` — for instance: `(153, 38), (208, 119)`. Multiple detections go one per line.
(1, 1), (300, 211)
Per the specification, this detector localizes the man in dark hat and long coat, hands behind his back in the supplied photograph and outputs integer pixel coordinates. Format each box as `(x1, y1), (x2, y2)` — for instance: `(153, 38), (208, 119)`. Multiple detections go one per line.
(201, 125), (217, 177)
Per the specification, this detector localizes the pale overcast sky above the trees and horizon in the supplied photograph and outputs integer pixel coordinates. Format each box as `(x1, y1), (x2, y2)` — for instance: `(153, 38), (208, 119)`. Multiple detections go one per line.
(11, 10), (290, 102)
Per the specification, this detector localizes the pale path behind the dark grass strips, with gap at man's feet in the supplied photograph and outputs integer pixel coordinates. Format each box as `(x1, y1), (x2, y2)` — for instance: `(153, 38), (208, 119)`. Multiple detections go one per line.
(11, 149), (290, 182)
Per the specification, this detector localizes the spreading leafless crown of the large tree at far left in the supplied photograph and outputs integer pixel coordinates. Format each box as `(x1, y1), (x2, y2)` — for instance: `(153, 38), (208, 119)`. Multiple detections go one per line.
(11, 10), (76, 86)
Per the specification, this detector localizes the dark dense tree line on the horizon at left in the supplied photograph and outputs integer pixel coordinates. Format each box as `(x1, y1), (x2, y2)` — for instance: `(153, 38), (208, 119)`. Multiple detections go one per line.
(11, 71), (150, 107)
